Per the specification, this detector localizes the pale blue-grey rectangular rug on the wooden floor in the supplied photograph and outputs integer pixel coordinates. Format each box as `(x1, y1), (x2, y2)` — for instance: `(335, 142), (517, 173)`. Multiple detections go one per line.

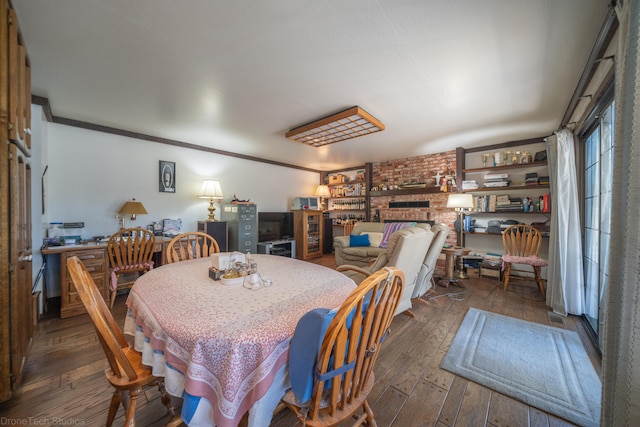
(442, 308), (602, 427)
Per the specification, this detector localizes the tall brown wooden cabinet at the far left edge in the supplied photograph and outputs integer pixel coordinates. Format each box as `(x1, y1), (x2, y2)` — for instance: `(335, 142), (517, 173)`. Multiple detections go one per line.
(0, 0), (34, 401)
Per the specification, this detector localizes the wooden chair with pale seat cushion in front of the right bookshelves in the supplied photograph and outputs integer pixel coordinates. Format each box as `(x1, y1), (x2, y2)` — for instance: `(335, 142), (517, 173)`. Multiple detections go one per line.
(502, 224), (548, 296)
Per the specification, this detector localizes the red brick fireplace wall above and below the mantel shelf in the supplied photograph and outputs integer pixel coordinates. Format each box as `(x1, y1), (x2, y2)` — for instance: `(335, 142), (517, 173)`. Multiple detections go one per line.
(370, 150), (456, 245)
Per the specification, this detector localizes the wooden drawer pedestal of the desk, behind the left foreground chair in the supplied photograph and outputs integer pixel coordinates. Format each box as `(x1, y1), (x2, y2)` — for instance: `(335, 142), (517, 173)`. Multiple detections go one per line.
(60, 247), (109, 318)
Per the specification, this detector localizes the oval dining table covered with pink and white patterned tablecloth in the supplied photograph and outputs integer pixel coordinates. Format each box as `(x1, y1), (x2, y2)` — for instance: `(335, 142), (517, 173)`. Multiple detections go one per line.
(124, 254), (356, 427)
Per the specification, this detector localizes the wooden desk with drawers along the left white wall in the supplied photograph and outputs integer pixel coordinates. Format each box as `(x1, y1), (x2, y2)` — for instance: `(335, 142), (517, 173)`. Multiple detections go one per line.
(41, 236), (171, 318)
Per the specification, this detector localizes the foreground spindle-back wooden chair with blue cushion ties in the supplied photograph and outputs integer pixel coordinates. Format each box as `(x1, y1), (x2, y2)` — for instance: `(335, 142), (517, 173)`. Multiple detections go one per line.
(283, 267), (404, 427)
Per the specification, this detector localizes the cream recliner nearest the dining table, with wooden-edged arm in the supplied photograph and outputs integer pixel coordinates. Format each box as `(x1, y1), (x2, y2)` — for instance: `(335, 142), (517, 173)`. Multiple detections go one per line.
(337, 224), (434, 317)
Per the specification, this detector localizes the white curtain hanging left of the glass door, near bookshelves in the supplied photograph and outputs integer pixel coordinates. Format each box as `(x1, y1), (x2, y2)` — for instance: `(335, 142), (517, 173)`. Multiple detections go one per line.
(546, 129), (585, 315)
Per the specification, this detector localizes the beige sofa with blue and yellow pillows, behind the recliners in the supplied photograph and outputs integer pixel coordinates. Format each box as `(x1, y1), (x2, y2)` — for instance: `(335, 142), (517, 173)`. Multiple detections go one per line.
(333, 221), (431, 267)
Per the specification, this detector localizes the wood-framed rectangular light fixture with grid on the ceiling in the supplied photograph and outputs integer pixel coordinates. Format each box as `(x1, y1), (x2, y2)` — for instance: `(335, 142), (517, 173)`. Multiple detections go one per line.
(284, 107), (384, 147)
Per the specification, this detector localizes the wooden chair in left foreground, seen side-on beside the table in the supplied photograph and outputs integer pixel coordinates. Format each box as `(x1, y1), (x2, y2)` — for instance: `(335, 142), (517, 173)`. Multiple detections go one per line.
(67, 256), (180, 427)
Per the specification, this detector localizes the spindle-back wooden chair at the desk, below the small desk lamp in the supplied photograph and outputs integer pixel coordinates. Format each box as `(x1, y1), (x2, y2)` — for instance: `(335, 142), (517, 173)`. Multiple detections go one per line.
(107, 228), (156, 307)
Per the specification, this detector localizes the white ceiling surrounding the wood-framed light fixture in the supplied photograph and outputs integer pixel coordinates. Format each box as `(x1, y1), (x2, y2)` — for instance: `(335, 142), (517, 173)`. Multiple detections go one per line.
(12, 0), (608, 170)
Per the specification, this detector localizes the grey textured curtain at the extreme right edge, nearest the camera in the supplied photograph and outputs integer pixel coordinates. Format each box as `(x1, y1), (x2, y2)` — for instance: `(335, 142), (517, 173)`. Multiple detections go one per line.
(600, 0), (640, 426)
